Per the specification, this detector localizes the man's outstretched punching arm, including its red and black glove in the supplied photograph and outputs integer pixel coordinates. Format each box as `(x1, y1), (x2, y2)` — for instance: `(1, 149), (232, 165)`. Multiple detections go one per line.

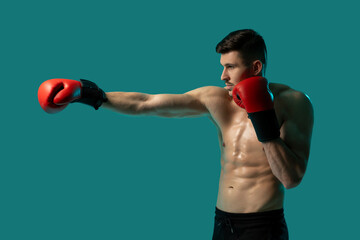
(38, 78), (212, 117)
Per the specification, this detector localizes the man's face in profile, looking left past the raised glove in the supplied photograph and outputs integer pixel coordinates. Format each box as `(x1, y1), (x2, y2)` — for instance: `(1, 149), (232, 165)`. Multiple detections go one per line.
(220, 51), (252, 96)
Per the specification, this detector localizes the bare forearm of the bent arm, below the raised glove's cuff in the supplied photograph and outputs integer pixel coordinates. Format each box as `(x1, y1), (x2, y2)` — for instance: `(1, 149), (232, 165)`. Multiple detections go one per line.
(263, 138), (306, 189)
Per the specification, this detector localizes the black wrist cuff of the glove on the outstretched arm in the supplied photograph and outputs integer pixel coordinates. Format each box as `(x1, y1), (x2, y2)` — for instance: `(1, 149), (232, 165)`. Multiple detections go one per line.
(74, 79), (107, 110)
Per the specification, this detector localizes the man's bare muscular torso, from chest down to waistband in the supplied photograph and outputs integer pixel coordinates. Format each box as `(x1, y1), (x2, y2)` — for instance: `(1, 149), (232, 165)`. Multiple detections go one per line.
(204, 83), (291, 213)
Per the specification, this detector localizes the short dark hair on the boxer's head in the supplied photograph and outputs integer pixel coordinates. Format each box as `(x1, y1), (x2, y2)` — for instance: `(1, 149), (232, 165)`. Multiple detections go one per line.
(216, 29), (267, 70)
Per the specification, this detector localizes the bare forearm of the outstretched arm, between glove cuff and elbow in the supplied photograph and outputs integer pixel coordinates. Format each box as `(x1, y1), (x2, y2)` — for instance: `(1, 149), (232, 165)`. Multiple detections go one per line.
(102, 92), (150, 115)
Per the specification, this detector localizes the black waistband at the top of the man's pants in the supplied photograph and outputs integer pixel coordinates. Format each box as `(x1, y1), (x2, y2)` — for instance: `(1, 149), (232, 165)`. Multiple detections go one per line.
(215, 208), (284, 221)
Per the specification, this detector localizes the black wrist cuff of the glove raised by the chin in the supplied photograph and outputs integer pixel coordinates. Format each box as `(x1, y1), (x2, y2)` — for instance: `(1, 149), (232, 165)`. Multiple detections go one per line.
(248, 109), (280, 142)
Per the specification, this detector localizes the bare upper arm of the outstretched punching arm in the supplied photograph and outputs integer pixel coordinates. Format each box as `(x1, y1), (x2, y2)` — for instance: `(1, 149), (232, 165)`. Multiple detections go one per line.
(144, 90), (208, 117)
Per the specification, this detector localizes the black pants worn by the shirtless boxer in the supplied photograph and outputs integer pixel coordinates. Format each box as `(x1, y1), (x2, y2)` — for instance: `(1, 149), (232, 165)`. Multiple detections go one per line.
(212, 208), (289, 240)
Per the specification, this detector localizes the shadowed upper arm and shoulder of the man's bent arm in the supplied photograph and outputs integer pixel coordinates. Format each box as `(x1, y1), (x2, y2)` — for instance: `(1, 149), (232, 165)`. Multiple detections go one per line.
(280, 92), (314, 162)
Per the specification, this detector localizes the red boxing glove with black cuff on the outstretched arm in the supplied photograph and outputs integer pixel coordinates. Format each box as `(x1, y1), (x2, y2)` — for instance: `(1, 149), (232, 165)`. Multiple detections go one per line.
(38, 78), (107, 113)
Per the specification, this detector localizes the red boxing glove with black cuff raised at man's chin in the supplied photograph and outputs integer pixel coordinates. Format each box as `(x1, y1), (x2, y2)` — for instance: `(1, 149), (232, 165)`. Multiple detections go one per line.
(233, 76), (280, 142)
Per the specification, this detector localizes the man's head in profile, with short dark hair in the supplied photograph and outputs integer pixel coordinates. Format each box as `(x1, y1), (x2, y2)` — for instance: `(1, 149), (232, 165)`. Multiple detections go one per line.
(216, 29), (267, 95)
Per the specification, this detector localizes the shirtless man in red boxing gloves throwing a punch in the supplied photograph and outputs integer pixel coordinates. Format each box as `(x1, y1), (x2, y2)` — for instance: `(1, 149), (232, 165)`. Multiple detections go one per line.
(38, 29), (313, 240)
